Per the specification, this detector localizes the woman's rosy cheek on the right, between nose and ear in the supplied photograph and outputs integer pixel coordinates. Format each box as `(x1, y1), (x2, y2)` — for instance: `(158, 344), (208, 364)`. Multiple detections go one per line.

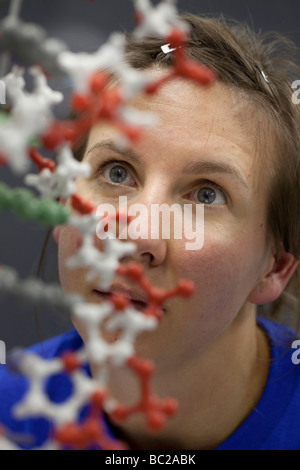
(178, 214), (267, 290)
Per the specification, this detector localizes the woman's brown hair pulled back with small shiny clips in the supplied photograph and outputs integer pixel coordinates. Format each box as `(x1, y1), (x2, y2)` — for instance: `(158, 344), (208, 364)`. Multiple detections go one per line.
(44, 14), (300, 330)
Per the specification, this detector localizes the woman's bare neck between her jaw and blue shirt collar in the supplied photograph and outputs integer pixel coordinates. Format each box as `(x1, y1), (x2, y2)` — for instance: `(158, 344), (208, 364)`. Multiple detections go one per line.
(98, 311), (269, 450)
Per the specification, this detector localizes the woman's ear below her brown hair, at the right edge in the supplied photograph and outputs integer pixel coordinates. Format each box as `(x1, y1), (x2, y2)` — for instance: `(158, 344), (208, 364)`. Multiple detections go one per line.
(248, 251), (299, 305)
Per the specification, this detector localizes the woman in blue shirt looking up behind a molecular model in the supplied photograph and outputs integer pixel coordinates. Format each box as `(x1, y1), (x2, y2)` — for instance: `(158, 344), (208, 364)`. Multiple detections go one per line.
(0, 15), (300, 450)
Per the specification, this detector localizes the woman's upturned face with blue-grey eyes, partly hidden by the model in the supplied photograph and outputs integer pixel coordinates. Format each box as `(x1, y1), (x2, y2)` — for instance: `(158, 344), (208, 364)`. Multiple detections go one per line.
(59, 80), (272, 368)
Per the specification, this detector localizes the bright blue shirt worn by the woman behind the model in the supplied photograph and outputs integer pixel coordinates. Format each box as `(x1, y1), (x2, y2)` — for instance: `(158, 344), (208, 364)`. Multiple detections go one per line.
(0, 318), (300, 450)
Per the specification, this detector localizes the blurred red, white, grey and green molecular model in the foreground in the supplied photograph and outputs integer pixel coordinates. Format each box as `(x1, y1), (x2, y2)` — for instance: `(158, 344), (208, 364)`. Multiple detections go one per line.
(0, 0), (214, 449)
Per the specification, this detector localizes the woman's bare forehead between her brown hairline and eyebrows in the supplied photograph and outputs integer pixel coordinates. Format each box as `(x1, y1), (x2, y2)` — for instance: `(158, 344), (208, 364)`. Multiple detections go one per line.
(88, 76), (266, 188)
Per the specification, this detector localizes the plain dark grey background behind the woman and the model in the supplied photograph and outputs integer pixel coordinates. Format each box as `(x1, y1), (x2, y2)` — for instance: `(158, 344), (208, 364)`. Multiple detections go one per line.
(0, 0), (300, 350)
